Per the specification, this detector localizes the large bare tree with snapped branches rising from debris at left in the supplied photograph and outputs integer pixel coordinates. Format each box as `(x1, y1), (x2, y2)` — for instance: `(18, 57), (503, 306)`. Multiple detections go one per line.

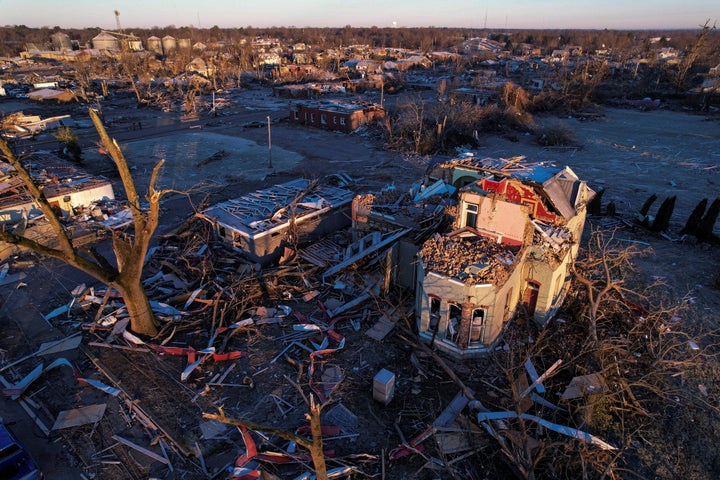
(0, 109), (169, 336)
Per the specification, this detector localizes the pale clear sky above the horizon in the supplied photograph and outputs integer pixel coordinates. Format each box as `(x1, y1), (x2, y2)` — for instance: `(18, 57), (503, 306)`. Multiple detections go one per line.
(0, 0), (720, 29)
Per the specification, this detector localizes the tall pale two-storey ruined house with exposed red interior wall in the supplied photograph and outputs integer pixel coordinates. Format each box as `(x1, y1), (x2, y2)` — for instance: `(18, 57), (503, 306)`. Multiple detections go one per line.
(416, 156), (594, 358)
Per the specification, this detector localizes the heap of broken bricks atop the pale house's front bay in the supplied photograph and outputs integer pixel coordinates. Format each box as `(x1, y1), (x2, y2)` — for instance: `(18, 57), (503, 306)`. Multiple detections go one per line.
(419, 235), (519, 285)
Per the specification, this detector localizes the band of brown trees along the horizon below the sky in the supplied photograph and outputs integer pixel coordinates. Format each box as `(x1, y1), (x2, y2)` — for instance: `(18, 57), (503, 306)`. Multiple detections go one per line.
(0, 24), (720, 66)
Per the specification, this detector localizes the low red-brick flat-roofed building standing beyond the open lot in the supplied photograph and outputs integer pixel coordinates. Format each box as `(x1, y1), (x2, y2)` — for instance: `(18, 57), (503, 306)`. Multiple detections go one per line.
(290, 101), (385, 133)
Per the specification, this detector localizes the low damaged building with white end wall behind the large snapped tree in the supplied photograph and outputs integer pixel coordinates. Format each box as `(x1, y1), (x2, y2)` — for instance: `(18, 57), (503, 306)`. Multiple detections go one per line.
(0, 153), (115, 223)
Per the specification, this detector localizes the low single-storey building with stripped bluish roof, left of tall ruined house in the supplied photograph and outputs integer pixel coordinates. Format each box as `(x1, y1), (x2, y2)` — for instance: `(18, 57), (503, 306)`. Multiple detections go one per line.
(200, 179), (353, 265)
